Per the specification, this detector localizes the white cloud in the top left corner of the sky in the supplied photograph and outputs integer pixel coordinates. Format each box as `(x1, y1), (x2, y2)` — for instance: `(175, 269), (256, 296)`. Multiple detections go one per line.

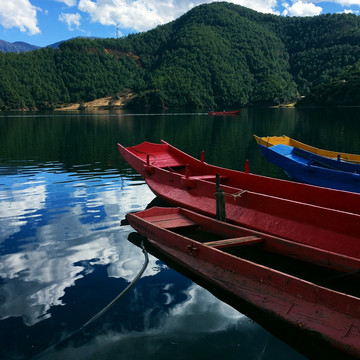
(0, 0), (41, 35)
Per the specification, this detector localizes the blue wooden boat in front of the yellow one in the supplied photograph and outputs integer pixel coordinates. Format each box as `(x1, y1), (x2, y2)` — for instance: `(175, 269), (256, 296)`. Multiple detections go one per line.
(255, 144), (360, 192)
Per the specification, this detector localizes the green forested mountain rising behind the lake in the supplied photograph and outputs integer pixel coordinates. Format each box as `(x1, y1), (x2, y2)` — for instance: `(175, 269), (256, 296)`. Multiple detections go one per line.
(0, 2), (360, 109)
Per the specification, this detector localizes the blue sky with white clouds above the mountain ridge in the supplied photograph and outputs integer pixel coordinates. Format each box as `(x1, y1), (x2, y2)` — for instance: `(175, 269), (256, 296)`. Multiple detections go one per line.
(0, 0), (360, 46)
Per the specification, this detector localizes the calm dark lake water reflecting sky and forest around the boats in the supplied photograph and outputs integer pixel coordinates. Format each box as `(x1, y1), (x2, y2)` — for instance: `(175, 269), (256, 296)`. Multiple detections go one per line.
(0, 108), (360, 360)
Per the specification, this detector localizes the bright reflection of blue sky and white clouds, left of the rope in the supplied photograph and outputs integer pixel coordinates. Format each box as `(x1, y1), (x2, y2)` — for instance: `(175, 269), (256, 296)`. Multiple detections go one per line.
(0, 169), (158, 325)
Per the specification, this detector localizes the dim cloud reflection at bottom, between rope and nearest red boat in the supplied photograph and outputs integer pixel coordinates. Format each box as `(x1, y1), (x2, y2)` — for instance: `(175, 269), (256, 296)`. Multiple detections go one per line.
(40, 284), (305, 360)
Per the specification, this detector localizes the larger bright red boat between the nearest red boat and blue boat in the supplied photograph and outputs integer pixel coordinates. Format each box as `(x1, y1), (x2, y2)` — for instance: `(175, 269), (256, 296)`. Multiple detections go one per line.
(118, 142), (360, 259)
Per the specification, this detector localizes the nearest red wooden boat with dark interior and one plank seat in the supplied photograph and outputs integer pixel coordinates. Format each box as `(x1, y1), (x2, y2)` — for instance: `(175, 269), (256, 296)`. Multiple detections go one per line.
(127, 208), (360, 357)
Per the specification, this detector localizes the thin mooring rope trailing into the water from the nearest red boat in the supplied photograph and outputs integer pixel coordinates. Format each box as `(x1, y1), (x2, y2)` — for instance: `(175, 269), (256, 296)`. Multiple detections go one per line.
(32, 241), (149, 360)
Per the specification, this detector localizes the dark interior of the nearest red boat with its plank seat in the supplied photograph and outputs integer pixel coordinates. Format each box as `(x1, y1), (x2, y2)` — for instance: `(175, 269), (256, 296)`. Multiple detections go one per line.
(147, 214), (360, 297)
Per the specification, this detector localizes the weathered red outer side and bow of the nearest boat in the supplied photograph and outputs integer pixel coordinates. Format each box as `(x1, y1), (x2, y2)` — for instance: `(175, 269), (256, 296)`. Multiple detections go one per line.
(128, 209), (360, 357)
